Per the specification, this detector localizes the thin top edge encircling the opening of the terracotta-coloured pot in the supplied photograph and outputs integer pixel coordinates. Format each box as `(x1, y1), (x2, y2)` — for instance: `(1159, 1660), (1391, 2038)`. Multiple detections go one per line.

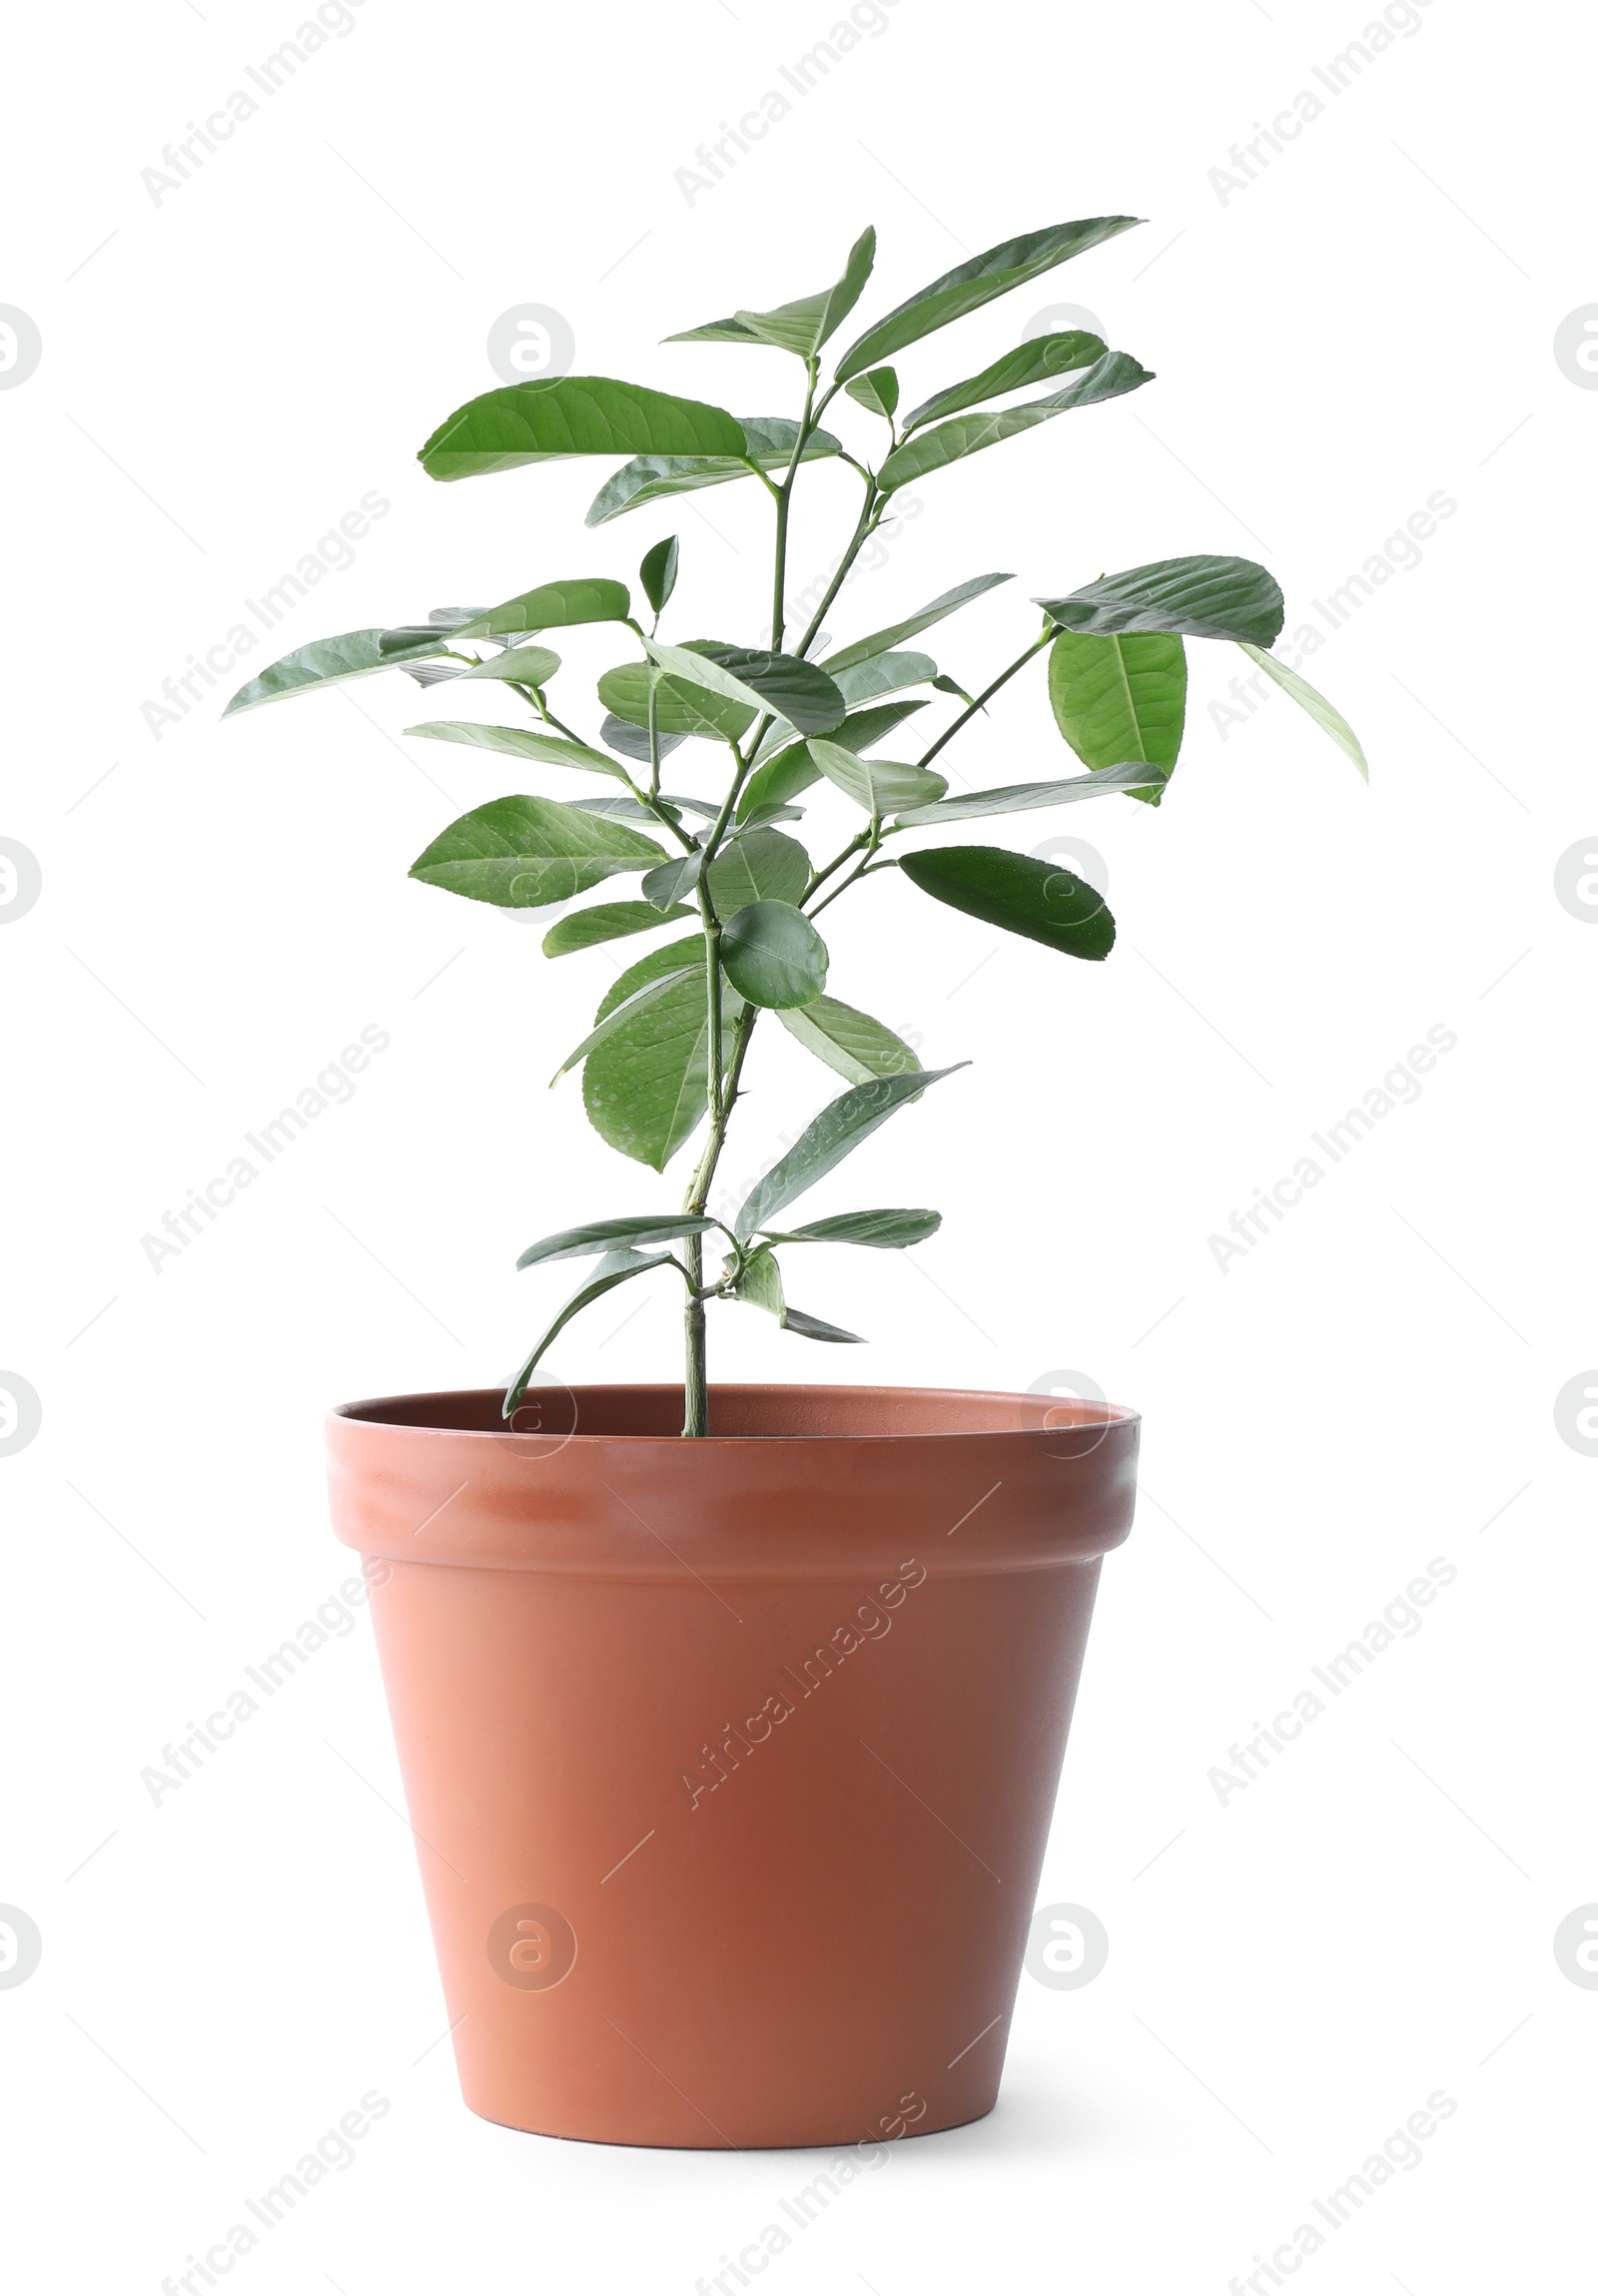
(329, 1380), (1144, 1449)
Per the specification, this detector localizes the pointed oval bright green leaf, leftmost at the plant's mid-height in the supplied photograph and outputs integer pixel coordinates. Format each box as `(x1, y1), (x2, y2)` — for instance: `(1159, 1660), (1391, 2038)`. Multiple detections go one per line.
(410, 797), (666, 909)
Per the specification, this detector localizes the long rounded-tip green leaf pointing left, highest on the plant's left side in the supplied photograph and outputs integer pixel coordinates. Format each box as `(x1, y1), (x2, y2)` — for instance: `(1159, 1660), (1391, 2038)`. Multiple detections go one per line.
(415, 375), (744, 479)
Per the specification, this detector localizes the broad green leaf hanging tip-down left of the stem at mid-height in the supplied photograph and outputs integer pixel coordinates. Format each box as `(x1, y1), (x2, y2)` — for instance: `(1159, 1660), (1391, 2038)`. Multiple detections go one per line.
(583, 935), (744, 1170)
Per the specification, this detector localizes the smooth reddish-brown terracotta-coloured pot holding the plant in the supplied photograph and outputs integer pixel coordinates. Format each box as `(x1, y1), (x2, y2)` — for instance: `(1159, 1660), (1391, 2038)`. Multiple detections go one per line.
(329, 1387), (1137, 2147)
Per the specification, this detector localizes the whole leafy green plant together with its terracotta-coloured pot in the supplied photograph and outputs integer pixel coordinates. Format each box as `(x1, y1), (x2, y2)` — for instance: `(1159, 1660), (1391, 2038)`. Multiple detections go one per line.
(228, 216), (1364, 2147)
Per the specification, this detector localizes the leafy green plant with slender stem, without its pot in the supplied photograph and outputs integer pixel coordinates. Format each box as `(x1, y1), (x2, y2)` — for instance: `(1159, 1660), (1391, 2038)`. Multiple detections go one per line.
(225, 216), (1364, 1435)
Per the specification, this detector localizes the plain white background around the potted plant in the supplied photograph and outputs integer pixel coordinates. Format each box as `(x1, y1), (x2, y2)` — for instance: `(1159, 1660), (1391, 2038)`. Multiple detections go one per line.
(0, 0), (1598, 2296)
